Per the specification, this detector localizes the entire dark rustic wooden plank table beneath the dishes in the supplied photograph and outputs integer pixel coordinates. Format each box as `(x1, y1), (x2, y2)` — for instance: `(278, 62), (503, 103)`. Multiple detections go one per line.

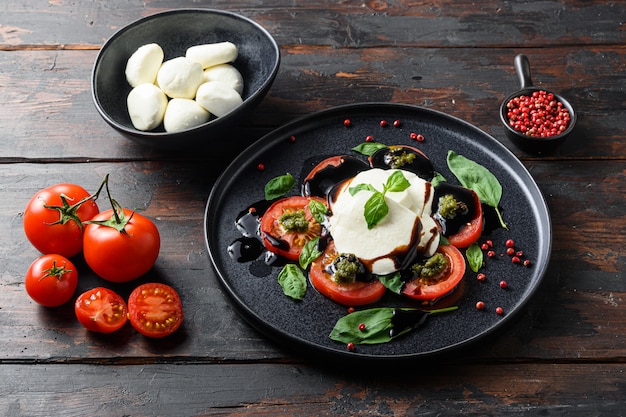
(0, 0), (626, 416)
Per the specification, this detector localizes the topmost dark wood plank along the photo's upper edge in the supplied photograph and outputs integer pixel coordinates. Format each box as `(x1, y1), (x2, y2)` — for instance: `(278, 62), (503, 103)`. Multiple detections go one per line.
(0, 0), (626, 49)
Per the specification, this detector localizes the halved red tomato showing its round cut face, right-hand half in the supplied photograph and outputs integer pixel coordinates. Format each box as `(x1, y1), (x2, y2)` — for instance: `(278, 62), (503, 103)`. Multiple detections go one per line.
(128, 283), (183, 337)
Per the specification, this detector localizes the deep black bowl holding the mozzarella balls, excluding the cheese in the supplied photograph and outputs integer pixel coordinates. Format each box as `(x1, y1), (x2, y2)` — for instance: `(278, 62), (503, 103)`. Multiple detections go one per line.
(91, 9), (280, 150)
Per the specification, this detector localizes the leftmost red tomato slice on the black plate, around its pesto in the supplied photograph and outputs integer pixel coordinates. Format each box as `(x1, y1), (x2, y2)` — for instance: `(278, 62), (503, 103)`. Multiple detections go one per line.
(261, 196), (326, 261)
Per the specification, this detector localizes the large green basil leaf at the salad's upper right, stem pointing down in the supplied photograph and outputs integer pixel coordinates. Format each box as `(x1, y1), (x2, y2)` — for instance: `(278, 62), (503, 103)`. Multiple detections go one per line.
(447, 151), (508, 229)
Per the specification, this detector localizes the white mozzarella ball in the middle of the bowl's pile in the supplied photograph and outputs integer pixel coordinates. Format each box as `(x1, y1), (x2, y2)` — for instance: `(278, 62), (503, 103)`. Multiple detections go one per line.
(157, 57), (204, 99)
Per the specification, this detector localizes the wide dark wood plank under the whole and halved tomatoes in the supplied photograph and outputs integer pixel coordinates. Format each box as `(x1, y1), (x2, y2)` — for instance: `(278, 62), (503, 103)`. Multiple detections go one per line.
(0, 161), (626, 363)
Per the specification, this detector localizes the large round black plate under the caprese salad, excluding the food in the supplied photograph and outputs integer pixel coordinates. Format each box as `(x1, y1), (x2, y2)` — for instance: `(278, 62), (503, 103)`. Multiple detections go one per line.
(205, 103), (552, 361)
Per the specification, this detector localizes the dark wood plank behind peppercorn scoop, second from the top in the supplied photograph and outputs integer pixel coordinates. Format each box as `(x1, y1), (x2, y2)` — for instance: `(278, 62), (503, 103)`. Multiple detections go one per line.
(0, 46), (626, 161)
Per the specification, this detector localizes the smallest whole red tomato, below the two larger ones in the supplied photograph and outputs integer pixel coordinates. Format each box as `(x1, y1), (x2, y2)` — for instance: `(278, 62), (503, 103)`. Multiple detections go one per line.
(24, 254), (78, 307)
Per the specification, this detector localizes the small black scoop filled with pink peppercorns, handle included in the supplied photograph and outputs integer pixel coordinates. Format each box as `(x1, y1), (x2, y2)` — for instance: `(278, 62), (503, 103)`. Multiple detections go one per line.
(500, 54), (576, 154)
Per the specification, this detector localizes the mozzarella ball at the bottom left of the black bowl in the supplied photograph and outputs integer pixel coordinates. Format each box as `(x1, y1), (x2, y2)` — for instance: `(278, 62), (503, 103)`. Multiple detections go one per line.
(126, 83), (167, 131)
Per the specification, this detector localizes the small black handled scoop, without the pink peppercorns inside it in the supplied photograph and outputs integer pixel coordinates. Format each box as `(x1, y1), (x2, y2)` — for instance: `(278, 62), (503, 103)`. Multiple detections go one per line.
(500, 54), (576, 154)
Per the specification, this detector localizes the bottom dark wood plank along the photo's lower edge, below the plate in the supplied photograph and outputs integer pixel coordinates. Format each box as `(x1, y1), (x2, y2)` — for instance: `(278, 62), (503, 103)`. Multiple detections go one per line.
(0, 363), (626, 417)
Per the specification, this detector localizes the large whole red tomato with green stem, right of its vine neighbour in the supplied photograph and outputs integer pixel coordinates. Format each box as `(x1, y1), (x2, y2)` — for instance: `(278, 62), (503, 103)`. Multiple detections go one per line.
(83, 209), (161, 282)
